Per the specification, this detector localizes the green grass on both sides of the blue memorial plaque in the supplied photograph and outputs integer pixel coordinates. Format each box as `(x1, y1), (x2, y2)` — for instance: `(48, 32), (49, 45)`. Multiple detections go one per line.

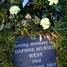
(0, 23), (67, 67)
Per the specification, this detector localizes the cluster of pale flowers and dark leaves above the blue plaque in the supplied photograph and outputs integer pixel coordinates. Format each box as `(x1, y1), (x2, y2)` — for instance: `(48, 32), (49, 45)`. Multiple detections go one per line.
(0, 0), (61, 36)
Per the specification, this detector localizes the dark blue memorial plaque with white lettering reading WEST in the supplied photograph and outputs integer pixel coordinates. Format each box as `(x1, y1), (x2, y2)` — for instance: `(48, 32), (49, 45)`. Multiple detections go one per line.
(14, 36), (57, 67)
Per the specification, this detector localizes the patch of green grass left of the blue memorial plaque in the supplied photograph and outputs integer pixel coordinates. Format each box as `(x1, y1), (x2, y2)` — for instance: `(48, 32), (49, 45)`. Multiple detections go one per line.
(0, 30), (14, 67)
